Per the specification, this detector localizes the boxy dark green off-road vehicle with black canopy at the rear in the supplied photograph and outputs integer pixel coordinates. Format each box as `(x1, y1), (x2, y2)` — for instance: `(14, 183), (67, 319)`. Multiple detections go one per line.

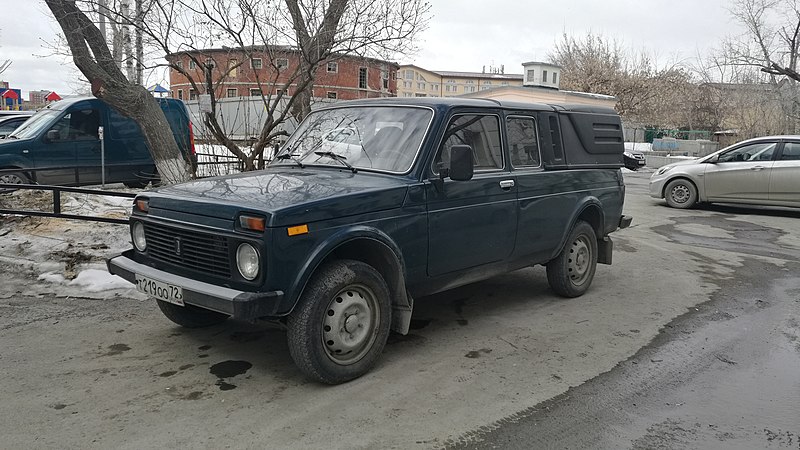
(108, 98), (631, 383)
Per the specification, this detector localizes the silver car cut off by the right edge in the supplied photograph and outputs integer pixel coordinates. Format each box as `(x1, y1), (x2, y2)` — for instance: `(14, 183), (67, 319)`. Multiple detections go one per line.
(650, 136), (800, 208)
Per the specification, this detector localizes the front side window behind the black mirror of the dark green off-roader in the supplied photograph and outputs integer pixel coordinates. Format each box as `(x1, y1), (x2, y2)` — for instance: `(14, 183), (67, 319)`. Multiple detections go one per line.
(434, 114), (503, 173)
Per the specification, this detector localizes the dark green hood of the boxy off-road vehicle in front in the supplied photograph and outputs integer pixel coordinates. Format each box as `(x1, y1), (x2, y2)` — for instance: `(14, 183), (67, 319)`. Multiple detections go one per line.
(142, 167), (408, 227)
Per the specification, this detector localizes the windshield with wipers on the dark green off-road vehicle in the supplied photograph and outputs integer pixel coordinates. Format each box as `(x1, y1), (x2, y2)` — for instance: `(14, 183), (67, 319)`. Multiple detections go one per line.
(273, 106), (433, 173)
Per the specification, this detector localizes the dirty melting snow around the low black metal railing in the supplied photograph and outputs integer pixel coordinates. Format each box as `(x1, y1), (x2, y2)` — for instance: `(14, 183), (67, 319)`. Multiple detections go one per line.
(0, 186), (138, 298)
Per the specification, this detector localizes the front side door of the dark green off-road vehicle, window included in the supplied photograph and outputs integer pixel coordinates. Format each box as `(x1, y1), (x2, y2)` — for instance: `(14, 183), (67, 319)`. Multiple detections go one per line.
(426, 113), (517, 276)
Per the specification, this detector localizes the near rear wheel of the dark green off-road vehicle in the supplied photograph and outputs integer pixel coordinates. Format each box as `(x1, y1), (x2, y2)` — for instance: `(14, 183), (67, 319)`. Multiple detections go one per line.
(547, 220), (597, 297)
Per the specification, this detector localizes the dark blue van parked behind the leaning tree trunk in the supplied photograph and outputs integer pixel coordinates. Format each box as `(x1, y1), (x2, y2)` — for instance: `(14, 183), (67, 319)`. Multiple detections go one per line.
(0, 97), (194, 187)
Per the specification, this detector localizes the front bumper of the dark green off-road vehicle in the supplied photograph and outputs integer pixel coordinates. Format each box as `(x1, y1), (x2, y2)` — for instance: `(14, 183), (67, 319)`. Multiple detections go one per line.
(106, 250), (283, 320)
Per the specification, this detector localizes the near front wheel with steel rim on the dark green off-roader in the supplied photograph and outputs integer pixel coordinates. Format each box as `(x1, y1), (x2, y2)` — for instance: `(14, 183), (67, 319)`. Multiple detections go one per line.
(288, 260), (392, 384)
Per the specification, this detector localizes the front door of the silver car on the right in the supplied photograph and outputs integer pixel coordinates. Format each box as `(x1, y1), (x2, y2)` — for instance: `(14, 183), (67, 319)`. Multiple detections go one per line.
(704, 140), (779, 201)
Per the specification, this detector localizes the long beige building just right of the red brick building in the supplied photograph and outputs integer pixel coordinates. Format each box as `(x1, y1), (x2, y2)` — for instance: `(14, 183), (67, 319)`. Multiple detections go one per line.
(397, 64), (523, 97)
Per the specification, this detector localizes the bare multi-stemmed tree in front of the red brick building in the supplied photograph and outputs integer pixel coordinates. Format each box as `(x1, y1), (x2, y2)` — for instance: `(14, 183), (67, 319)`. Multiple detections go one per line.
(83, 0), (430, 170)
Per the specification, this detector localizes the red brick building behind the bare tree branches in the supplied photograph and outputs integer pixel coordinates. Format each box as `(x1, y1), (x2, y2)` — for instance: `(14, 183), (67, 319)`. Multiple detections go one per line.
(167, 47), (398, 100)
